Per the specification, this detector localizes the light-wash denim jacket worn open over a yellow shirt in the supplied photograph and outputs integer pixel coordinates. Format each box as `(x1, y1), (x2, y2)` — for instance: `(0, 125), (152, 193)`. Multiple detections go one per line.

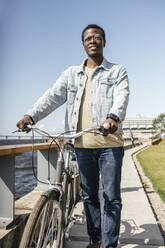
(26, 58), (129, 133)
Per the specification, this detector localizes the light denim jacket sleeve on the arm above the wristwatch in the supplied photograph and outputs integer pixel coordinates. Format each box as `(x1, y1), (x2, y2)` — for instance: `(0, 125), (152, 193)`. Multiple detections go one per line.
(110, 66), (130, 121)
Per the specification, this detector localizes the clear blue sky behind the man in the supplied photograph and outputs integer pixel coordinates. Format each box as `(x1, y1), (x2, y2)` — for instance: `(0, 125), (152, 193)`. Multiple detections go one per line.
(0, 0), (165, 134)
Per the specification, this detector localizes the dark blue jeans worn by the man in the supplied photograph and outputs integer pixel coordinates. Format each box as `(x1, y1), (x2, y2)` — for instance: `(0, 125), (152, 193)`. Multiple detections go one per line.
(75, 147), (124, 248)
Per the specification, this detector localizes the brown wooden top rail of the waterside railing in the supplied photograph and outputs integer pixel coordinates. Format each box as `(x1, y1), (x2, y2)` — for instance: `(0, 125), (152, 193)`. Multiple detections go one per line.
(0, 143), (57, 156)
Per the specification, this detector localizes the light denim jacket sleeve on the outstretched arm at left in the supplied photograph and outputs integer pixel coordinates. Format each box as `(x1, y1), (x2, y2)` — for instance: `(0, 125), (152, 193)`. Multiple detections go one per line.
(26, 68), (69, 123)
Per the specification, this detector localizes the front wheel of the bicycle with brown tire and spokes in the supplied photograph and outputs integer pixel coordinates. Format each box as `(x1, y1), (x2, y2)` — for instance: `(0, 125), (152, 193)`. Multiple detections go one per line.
(19, 191), (64, 248)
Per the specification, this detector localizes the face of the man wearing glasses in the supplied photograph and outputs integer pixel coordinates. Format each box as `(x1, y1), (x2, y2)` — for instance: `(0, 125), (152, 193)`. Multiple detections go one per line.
(83, 28), (105, 56)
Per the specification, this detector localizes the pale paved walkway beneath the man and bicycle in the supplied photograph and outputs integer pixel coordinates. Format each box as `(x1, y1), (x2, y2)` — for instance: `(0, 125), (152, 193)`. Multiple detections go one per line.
(65, 145), (165, 248)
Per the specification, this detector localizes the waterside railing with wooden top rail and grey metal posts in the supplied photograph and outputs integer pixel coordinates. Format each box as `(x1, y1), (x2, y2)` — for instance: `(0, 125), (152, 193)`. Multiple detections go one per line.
(0, 143), (58, 228)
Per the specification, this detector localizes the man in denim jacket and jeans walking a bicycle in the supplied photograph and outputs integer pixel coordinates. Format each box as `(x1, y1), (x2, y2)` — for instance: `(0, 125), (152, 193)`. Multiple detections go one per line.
(17, 24), (129, 248)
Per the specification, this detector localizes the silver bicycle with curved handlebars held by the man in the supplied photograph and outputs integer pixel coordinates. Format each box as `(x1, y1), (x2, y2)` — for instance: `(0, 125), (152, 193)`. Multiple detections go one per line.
(17, 123), (113, 248)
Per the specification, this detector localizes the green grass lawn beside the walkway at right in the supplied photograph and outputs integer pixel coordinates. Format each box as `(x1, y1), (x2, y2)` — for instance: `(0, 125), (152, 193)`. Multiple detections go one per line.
(136, 141), (165, 202)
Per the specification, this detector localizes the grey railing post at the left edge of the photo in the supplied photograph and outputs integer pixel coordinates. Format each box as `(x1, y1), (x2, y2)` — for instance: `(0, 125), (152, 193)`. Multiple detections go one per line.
(0, 155), (15, 228)
